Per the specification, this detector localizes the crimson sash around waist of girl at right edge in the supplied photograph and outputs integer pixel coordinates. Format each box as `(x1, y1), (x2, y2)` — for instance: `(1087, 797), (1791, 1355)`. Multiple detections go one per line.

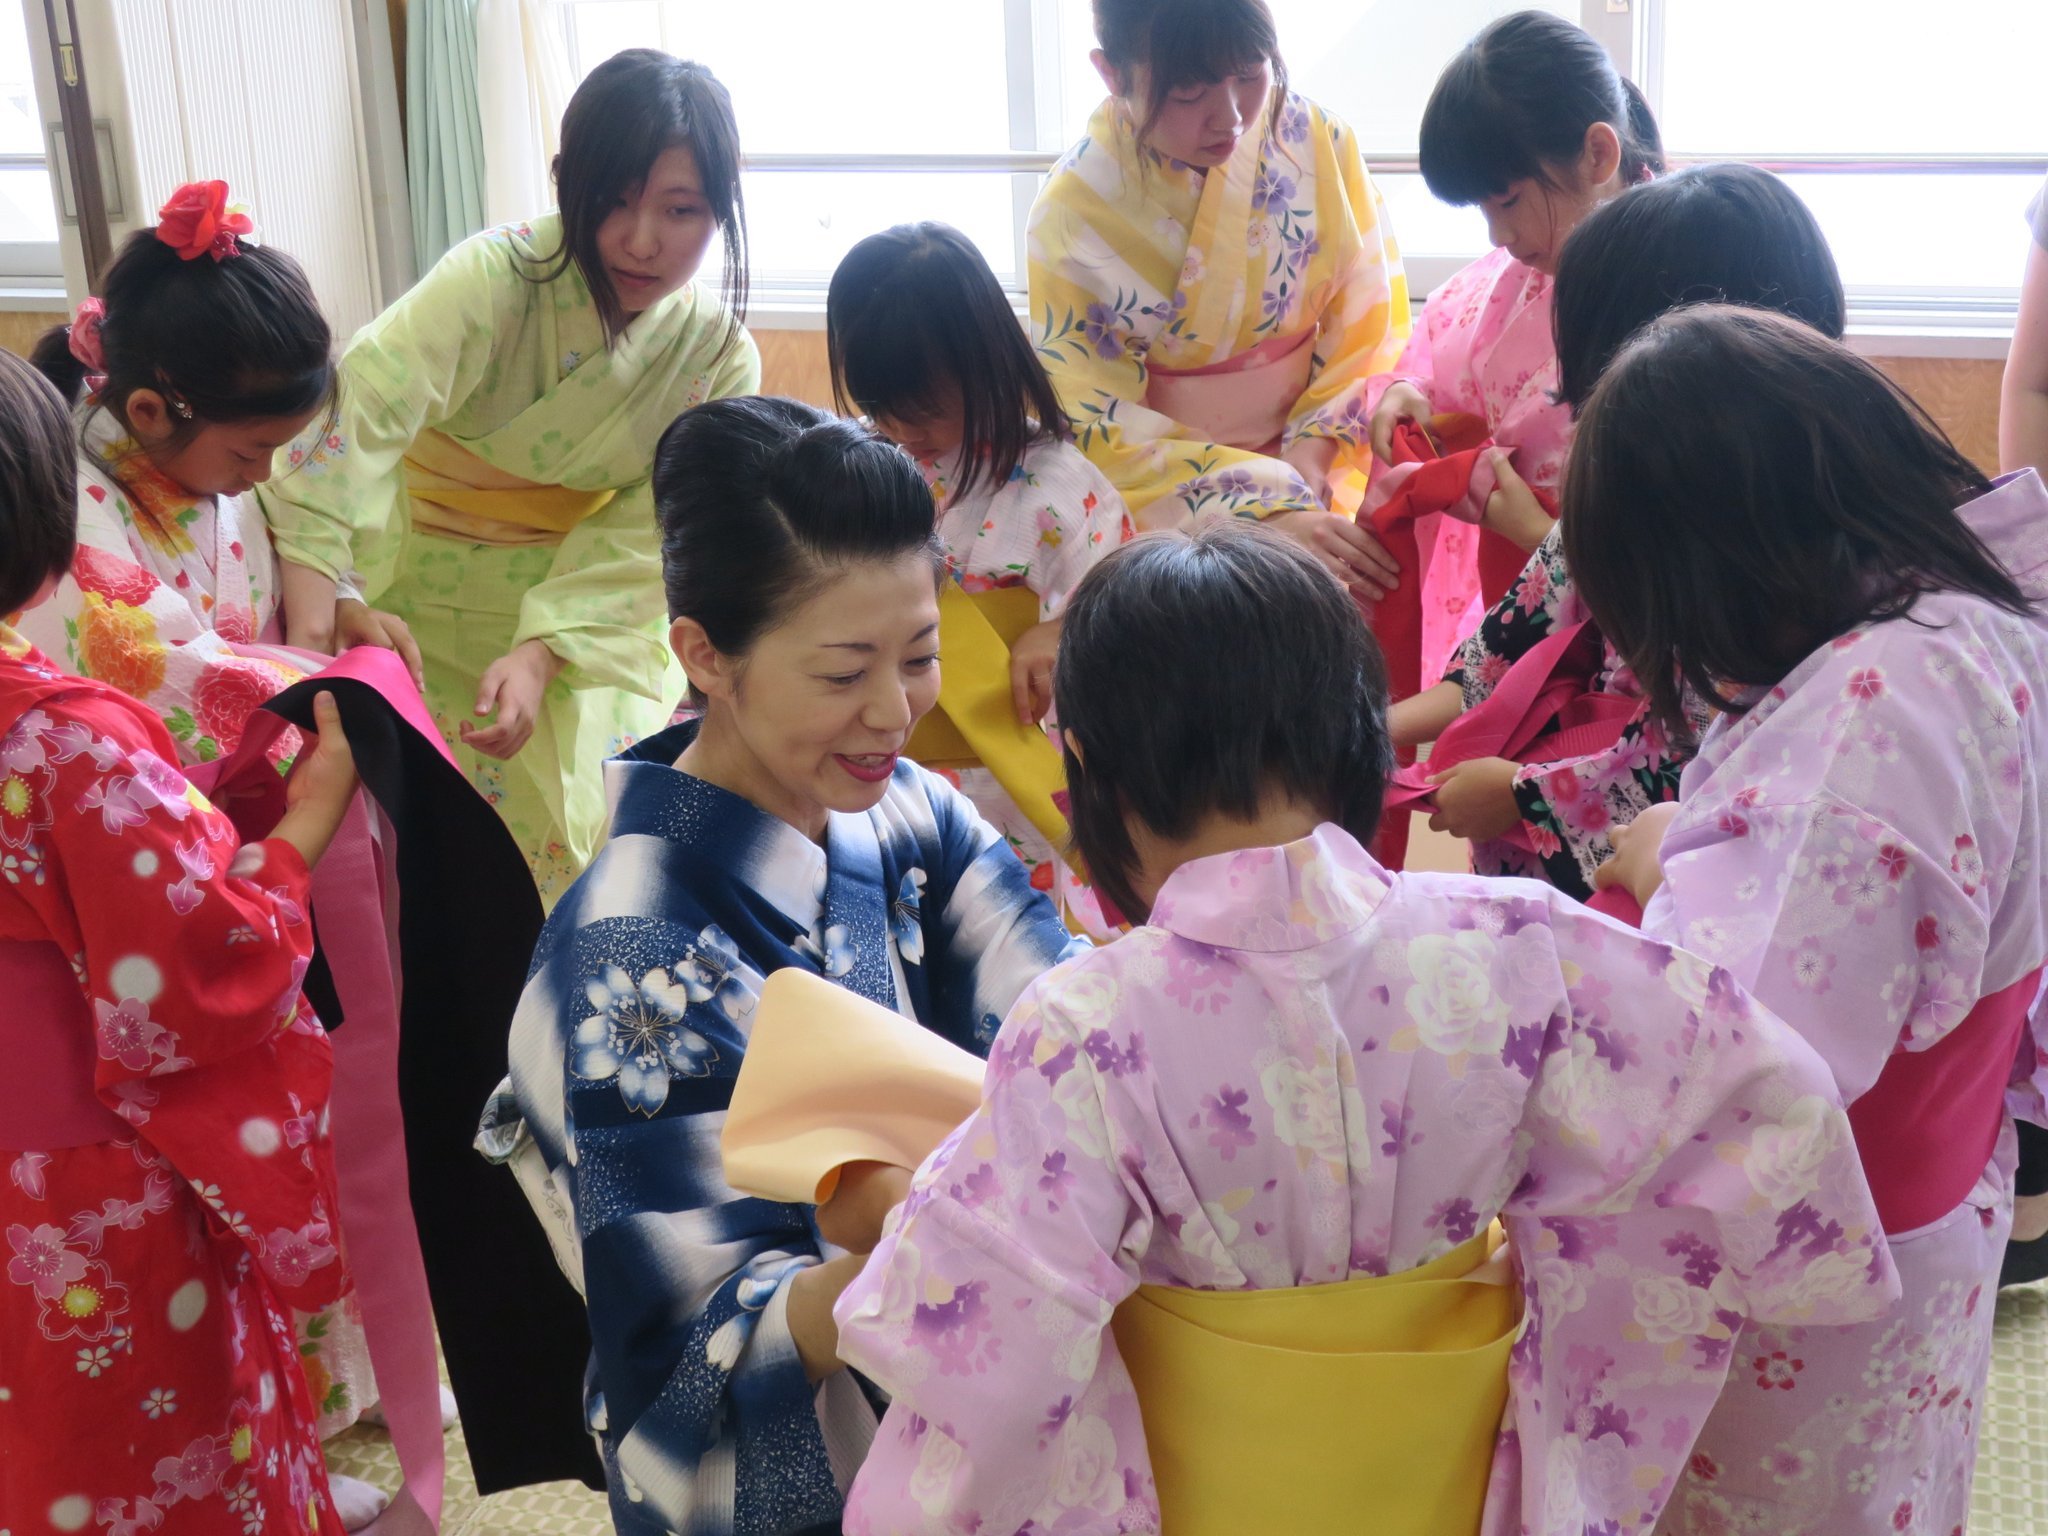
(1849, 971), (2042, 1235)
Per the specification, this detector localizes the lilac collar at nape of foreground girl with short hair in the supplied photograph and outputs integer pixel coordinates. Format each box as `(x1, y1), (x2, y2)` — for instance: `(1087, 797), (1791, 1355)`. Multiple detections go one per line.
(1149, 821), (1393, 952)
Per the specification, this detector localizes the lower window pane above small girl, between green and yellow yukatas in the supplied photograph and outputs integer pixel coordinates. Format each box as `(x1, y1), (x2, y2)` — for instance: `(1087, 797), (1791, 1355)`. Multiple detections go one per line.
(745, 170), (1018, 283)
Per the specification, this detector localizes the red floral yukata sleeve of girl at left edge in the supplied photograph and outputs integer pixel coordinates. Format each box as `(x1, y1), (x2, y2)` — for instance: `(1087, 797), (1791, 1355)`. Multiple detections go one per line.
(16, 694), (346, 1311)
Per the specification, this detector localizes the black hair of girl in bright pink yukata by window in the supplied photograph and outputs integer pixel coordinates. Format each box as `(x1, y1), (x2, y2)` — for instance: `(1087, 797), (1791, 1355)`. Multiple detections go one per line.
(1421, 10), (1665, 207)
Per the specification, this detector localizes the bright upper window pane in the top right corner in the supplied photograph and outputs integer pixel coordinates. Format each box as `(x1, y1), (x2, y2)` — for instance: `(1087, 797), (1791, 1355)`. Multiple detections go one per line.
(1661, 0), (2048, 154)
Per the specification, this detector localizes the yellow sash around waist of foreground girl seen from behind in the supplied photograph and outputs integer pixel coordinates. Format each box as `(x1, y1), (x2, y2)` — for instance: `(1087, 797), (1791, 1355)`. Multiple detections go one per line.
(1112, 1227), (1520, 1536)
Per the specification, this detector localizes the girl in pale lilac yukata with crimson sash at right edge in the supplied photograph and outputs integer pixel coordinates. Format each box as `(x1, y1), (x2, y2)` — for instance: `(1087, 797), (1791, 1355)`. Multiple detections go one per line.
(1563, 307), (2048, 1536)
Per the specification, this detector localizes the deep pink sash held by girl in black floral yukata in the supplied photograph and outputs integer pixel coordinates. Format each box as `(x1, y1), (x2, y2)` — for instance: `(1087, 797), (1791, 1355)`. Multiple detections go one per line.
(1382, 623), (1642, 850)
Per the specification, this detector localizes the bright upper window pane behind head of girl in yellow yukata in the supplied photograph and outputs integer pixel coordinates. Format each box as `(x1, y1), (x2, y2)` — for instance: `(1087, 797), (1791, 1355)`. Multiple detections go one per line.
(1047, 0), (1579, 156)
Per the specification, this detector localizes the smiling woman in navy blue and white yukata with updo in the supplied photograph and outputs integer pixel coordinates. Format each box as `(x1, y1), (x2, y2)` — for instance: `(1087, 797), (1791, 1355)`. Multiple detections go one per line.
(479, 397), (1077, 1536)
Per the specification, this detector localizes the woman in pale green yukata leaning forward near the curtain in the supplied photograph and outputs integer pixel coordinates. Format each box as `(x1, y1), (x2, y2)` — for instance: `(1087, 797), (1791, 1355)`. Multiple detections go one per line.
(262, 49), (760, 905)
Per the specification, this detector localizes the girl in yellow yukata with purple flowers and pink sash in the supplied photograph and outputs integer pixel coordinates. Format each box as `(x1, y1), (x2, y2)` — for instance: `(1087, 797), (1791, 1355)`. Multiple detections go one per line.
(1030, 0), (1409, 600)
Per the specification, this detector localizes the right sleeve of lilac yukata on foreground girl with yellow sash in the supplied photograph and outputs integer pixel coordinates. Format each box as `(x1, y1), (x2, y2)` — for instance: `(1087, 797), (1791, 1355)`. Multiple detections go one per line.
(1503, 925), (1898, 1536)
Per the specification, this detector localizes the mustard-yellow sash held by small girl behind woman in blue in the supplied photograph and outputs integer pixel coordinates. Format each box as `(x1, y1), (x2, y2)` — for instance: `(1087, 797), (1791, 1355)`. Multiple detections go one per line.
(903, 582), (1067, 848)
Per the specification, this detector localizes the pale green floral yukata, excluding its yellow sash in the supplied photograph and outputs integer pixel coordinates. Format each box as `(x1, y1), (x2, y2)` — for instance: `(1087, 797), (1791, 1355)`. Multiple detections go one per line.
(260, 213), (760, 901)
